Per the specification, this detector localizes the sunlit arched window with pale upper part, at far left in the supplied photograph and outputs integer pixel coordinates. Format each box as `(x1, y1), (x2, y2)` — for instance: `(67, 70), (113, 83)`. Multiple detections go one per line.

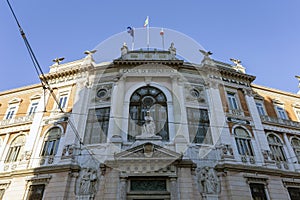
(5, 135), (25, 163)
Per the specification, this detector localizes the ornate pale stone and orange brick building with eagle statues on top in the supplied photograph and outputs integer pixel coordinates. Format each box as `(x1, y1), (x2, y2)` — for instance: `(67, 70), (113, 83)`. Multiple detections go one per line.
(0, 38), (300, 200)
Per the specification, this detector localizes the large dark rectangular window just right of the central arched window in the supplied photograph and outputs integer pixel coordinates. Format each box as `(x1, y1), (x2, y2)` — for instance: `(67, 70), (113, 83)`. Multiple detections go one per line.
(187, 108), (211, 144)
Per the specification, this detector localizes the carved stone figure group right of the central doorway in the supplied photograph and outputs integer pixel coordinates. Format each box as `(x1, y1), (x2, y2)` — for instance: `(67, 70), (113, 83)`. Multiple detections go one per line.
(197, 167), (221, 194)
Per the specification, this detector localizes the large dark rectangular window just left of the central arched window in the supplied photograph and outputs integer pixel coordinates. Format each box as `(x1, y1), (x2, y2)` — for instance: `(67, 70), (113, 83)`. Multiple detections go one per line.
(84, 107), (110, 144)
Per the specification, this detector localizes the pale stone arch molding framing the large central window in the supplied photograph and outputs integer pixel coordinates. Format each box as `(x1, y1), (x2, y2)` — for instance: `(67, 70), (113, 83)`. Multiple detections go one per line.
(120, 82), (175, 140)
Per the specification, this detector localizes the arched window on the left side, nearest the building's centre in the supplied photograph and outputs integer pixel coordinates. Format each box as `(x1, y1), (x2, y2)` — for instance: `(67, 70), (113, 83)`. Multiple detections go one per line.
(41, 127), (61, 156)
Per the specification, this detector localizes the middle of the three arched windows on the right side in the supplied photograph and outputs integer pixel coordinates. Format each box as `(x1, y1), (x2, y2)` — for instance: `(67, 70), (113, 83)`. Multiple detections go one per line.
(268, 134), (286, 161)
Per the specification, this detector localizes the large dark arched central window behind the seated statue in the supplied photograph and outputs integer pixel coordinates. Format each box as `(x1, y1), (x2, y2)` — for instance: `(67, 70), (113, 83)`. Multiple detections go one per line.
(127, 86), (169, 141)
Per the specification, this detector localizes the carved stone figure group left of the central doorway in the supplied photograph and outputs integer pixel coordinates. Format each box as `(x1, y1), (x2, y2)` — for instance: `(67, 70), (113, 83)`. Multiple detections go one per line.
(79, 168), (97, 195)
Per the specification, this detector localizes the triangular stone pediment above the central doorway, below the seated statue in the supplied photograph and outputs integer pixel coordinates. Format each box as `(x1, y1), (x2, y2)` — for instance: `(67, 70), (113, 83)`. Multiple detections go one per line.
(114, 142), (182, 161)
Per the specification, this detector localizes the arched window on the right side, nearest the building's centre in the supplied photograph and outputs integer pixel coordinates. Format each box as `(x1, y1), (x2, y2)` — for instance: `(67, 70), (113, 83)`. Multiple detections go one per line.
(234, 127), (254, 156)
